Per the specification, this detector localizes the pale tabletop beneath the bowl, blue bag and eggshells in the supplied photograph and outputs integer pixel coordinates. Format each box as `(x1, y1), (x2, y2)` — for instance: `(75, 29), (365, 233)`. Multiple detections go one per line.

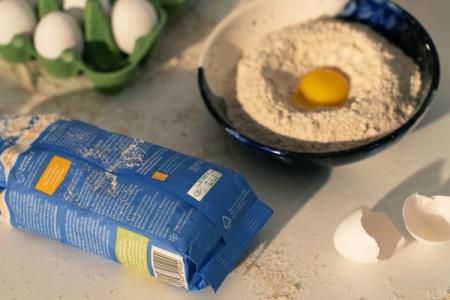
(0, 0), (450, 300)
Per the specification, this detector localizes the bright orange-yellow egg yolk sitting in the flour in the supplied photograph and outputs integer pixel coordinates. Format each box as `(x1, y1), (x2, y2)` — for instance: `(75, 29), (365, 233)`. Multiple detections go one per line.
(292, 67), (350, 108)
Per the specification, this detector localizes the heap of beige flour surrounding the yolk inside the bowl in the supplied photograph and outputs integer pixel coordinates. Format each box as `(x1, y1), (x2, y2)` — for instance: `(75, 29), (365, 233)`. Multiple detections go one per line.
(232, 18), (421, 152)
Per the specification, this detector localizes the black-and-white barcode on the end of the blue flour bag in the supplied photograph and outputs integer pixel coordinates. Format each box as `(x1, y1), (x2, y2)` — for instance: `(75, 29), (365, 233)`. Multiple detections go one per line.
(152, 246), (187, 288)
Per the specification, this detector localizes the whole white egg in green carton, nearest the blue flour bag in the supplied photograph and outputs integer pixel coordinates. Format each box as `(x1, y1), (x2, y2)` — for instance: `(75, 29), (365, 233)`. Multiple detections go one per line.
(34, 12), (84, 59)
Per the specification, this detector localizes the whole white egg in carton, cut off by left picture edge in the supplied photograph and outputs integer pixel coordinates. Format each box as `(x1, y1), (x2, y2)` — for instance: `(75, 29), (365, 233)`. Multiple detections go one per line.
(0, 0), (36, 45)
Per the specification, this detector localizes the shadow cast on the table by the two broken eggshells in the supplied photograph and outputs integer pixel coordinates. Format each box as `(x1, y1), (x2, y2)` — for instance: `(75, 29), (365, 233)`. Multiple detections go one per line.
(373, 160), (450, 245)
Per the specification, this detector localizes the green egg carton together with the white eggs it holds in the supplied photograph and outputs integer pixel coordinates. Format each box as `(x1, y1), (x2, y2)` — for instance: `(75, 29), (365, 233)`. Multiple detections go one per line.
(0, 0), (189, 92)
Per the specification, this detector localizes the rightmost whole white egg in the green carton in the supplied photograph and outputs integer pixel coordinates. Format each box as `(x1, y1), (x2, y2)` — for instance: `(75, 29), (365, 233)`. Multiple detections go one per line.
(112, 0), (158, 54)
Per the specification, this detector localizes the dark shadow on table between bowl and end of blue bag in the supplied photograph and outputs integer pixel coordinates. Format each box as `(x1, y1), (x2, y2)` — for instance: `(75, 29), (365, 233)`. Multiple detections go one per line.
(218, 137), (332, 261)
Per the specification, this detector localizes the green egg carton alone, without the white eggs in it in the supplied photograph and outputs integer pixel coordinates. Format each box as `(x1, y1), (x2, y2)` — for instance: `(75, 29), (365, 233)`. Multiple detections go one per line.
(0, 0), (190, 93)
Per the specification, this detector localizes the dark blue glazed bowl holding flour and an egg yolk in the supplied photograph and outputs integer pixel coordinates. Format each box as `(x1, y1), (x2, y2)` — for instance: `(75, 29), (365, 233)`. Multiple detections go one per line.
(198, 0), (439, 165)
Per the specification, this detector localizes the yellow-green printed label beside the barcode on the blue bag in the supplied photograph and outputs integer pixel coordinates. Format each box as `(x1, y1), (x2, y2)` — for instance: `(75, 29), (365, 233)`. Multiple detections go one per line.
(116, 227), (150, 274)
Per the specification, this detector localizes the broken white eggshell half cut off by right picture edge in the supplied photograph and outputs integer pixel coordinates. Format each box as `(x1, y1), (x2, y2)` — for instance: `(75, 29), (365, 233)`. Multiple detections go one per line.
(403, 194), (450, 244)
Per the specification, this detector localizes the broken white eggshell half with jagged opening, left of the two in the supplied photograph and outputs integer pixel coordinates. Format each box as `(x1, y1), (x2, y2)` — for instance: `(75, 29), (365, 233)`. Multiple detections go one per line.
(333, 206), (405, 263)
